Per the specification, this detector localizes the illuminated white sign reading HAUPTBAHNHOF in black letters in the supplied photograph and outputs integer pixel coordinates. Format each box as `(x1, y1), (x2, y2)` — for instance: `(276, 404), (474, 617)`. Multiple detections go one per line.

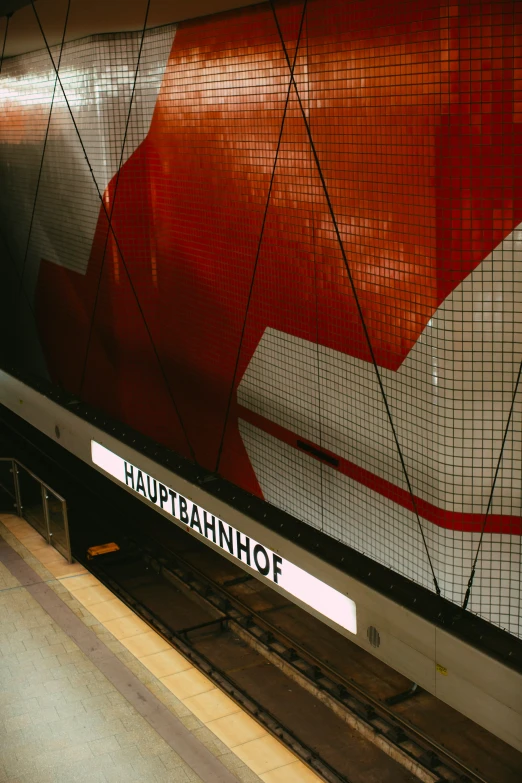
(91, 440), (357, 634)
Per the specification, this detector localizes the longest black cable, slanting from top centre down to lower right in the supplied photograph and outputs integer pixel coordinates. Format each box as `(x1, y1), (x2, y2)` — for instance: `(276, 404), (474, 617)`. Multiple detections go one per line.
(270, 0), (441, 595)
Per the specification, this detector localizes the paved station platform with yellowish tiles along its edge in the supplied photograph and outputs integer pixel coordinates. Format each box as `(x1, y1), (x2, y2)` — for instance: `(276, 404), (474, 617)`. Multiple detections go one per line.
(0, 514), (319, 783)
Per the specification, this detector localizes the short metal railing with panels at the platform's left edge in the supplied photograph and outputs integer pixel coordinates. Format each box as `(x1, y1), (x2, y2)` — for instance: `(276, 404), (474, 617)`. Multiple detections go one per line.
(0, 457), (72, 563)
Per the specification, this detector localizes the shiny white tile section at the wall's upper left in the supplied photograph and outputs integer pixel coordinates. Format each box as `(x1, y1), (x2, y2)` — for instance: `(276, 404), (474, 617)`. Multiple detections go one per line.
(0, 25), (175, 296)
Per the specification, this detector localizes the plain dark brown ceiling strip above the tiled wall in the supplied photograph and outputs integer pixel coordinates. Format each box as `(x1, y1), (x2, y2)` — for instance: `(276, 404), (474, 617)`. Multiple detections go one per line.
(0, 0), (259, 57)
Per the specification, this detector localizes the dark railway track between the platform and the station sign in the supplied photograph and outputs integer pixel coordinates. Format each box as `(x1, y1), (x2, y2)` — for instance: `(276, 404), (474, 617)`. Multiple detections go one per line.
(82, 544), (490, 783)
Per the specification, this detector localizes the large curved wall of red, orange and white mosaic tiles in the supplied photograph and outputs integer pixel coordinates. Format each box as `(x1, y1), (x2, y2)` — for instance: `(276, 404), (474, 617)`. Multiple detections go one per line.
(0, 0), (522, 635)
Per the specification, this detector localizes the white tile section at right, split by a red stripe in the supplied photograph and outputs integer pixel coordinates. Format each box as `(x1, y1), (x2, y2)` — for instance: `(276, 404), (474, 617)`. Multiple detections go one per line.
(238, 222), (522, 635)
